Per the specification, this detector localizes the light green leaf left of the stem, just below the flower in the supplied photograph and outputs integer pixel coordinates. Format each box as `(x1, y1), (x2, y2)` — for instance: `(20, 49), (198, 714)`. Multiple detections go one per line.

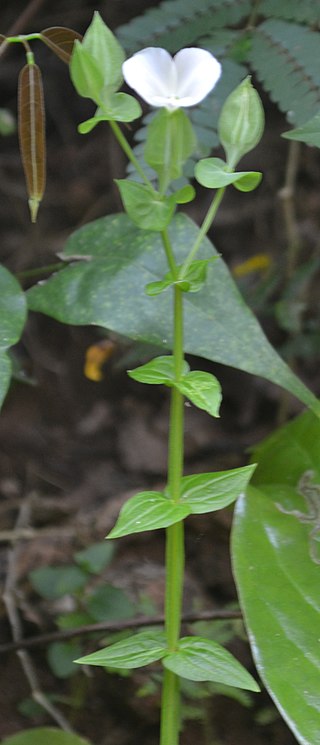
(115, 179), (176, 232)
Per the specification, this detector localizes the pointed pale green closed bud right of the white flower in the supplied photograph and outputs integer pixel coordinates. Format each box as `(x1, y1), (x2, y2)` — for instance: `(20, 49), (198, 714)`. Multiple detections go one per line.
(218, 77), (264, 169)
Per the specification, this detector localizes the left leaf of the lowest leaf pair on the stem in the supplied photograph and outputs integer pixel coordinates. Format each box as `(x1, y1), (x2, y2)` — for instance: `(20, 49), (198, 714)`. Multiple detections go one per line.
(75, 630), (166, 670)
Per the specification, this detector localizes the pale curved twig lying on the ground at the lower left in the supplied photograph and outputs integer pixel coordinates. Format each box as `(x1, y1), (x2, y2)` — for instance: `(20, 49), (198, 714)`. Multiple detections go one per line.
(3, 499), (73, 732)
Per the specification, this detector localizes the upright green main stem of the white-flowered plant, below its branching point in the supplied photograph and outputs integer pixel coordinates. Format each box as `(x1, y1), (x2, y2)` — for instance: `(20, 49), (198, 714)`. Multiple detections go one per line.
(160, 286), (184, 745)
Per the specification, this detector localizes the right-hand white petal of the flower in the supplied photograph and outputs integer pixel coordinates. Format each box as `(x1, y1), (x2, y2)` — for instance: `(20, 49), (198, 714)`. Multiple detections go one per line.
(173, 47), (221, 106)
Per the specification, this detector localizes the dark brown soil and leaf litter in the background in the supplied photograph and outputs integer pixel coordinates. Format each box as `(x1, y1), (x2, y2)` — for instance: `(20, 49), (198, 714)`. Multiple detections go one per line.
(0, 0), (320, 745)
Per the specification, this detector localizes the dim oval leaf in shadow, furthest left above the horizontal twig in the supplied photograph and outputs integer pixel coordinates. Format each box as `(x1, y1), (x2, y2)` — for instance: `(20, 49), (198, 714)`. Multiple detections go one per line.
(29, 564), (88, 600)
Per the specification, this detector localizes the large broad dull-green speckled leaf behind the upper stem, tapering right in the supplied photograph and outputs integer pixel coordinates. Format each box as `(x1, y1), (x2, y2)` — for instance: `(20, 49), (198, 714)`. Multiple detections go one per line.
(28, 214), (320, 415)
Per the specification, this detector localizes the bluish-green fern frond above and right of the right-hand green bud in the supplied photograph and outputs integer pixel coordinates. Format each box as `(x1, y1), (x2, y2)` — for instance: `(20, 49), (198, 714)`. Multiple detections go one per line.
(249, 20), (320, 125)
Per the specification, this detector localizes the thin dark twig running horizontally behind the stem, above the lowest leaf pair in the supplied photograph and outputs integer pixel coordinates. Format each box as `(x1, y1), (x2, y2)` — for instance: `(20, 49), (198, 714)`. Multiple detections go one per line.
(0, 610), (242, 654)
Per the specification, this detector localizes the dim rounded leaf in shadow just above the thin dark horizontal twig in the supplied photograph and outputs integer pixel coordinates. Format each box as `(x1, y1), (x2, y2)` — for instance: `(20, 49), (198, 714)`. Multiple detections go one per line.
(84, 584), (135, 620)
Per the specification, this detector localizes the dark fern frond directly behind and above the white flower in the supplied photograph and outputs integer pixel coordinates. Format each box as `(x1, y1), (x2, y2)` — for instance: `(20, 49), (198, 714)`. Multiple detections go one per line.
(116, 0), (251, 54)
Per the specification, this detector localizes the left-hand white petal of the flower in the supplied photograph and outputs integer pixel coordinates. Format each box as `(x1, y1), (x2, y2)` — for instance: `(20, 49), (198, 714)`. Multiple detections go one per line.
(122, 47), (177, 106)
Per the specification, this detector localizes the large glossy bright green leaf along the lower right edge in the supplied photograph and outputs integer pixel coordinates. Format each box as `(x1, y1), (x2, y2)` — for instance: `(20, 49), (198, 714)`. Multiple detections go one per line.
(232, 412), (320, 745)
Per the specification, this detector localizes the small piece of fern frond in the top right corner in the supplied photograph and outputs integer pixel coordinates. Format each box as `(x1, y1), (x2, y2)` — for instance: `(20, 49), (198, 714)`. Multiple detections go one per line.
(259, 0), (320, 25)
